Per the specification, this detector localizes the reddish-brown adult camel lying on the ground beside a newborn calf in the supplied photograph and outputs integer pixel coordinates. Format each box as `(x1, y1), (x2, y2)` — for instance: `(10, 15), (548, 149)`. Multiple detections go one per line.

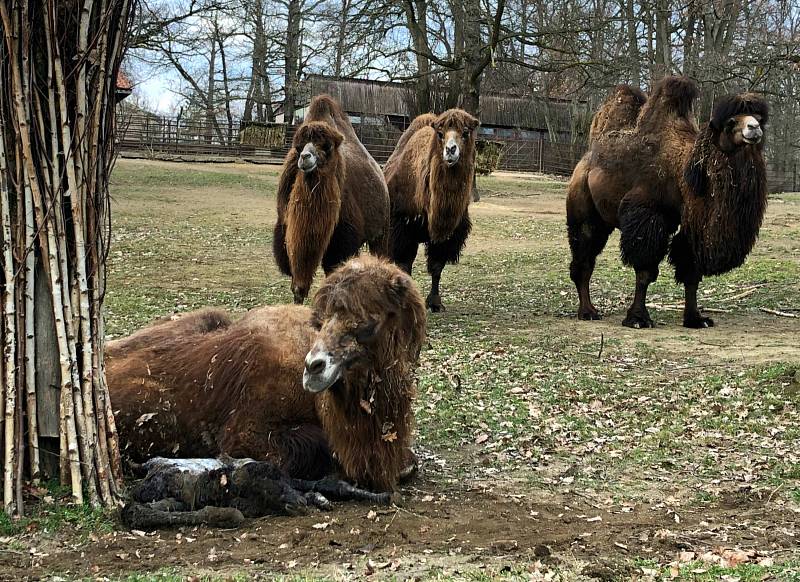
(107, 255), (426, 491)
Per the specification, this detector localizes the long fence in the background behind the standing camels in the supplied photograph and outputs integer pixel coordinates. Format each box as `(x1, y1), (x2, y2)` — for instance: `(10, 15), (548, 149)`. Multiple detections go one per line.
(117, 113), (800, 192)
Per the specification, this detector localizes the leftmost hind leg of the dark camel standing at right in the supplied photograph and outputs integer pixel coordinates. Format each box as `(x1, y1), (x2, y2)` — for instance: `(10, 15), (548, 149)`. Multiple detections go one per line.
(567, 160), (613, 320)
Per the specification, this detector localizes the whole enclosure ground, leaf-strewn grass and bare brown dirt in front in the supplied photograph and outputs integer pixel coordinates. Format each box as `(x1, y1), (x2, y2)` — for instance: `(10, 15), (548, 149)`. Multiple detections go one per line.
(0, 161), (800, 581)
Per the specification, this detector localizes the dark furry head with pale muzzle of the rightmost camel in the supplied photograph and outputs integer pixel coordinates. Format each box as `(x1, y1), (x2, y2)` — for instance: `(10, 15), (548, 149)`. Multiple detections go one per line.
(709, 93), (769, 153)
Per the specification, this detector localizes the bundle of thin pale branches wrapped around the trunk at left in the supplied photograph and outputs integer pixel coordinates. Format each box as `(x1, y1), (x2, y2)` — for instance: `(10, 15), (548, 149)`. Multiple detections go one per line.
(0, 0), (135, 514)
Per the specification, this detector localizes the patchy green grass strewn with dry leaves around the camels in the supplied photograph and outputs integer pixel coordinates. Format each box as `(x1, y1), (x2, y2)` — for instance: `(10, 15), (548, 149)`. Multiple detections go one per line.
(17, 160), (800, 581)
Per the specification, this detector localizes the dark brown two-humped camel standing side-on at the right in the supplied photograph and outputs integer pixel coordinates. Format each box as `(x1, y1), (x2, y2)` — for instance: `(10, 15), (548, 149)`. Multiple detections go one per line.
(567, 77), (769, 328)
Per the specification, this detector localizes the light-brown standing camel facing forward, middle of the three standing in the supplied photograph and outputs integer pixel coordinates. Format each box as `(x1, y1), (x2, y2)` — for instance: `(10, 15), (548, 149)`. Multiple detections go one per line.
(383, 109), (478, 312)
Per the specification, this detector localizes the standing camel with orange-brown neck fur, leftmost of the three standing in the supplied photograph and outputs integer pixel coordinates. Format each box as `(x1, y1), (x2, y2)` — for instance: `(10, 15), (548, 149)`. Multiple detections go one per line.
(272, 95), (389, 304)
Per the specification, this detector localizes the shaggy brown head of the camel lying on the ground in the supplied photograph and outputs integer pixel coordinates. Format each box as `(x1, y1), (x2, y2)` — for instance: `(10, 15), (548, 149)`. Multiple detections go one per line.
(303, 255), (426, 394)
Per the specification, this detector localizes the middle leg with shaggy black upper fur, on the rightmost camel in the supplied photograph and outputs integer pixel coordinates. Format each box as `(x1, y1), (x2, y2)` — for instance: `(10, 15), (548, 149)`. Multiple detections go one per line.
(619, 189), (677, 329)
